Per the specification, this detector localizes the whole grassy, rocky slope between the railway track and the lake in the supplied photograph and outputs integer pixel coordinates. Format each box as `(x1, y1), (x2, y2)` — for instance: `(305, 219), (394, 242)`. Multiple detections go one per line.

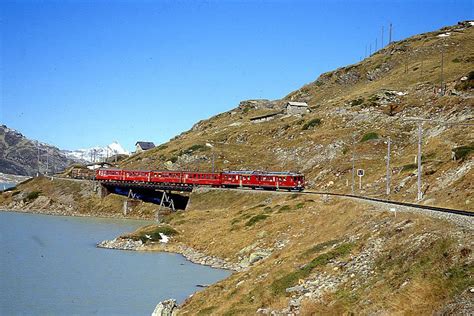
(133, 190), (474, 315)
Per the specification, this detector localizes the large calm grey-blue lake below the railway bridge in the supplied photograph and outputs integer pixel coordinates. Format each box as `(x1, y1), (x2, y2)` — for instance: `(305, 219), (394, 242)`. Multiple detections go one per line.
(0, 212), (230, 315)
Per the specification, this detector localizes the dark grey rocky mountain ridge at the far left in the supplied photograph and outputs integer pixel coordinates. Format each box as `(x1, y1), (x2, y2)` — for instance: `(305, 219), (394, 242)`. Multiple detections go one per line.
(0, 125), (75, 176)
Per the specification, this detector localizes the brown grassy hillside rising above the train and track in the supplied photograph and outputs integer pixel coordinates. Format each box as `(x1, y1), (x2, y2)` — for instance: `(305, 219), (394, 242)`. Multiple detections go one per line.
(122, 22), (474, 210)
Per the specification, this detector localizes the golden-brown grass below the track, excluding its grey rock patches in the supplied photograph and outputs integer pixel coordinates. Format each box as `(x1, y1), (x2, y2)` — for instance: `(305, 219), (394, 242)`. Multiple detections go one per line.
(139, 190), (472, 315)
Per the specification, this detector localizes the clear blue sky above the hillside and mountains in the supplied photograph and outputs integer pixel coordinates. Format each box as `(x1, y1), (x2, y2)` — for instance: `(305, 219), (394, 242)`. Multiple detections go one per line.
(0, 0), (473, 150)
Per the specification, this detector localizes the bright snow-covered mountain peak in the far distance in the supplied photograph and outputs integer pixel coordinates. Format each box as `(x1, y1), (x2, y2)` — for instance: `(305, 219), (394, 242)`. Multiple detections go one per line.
(63, 141), (130, 162)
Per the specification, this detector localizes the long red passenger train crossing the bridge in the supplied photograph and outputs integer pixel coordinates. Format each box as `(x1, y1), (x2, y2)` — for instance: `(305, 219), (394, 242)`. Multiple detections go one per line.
(95, 169), (304, 191)
